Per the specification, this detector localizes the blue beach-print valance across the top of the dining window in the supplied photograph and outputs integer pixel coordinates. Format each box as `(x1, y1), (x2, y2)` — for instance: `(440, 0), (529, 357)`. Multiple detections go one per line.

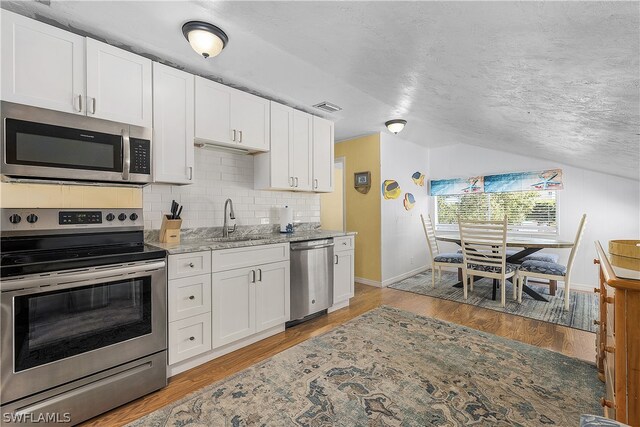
(429, 169), (564, 196)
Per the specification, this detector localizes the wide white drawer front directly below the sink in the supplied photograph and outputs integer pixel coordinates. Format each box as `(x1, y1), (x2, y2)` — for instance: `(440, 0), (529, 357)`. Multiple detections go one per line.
(211, 243), (289, 272)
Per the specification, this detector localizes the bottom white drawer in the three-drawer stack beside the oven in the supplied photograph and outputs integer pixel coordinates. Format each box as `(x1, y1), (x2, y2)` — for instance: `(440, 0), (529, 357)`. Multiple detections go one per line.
(169, 313), (211, 365)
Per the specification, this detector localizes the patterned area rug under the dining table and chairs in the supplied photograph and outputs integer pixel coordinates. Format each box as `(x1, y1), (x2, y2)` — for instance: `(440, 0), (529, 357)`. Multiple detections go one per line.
(389, 270), (599, 332)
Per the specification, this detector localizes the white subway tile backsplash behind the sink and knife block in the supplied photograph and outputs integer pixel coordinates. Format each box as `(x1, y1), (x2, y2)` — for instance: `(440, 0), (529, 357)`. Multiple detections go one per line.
(143, 148), (320, 229)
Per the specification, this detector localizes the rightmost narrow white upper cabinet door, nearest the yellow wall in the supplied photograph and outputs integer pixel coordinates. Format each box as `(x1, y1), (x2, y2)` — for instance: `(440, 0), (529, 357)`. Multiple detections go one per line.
(313, 117), (333, 192)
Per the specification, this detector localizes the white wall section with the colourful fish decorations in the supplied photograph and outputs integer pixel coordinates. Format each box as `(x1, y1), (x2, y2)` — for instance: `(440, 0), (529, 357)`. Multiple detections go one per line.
(380, 133), (429, 286)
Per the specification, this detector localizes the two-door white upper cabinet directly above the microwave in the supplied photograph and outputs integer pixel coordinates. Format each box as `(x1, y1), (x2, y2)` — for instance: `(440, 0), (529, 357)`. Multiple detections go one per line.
(2, 10), (152, 127)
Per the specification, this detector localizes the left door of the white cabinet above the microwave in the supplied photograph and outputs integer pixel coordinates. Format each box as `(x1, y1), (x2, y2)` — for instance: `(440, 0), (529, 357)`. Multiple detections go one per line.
(1, 10), (86, 114)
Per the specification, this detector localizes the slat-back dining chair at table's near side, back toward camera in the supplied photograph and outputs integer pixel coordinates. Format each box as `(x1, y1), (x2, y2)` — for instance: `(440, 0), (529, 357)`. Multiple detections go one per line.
(458, 216), (518, 307)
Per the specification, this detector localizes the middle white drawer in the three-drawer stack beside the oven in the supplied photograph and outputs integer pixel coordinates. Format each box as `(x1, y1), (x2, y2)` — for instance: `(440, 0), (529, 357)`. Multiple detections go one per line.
(168, 274), (211, 322)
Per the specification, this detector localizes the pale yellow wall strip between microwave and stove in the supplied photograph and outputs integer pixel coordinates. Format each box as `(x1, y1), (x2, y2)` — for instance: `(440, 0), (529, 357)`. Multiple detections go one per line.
(0, 182), (142, 209)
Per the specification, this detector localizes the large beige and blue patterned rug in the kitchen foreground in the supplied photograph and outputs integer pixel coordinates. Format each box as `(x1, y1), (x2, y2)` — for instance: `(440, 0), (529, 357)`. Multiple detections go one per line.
(130, 307), (604, 427)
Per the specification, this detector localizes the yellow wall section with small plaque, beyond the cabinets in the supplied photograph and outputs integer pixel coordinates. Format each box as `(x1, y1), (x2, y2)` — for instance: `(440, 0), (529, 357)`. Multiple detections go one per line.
(335, 133), (382, 282)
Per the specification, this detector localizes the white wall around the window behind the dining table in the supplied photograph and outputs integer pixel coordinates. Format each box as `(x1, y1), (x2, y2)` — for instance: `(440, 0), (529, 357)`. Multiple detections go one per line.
(428, 144), (640, 287)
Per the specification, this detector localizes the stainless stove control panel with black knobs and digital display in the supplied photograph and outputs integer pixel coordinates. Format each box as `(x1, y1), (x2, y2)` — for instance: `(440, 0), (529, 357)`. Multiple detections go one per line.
(0, 208), (144, 235)
